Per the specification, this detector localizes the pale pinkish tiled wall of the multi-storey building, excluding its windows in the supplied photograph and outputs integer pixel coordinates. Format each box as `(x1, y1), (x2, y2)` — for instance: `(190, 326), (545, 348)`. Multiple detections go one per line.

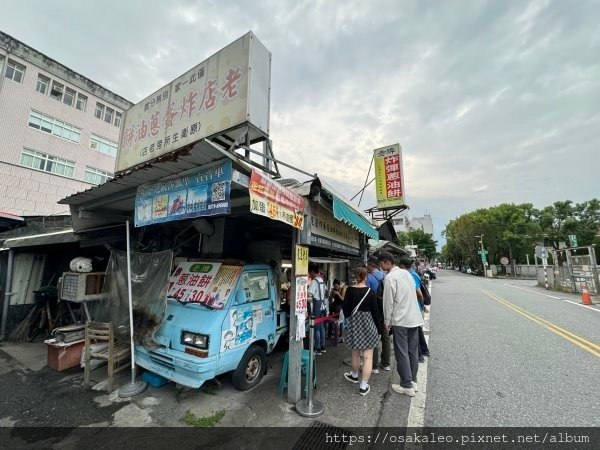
(0, 33), (131, 216)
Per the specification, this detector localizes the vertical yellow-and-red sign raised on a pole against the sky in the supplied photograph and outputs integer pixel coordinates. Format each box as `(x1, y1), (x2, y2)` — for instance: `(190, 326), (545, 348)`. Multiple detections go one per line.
(373, 144), (404, 209)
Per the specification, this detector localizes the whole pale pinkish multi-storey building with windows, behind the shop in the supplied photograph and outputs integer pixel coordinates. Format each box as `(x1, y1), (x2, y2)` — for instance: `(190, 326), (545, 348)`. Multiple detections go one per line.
(0, 31), (133, 216)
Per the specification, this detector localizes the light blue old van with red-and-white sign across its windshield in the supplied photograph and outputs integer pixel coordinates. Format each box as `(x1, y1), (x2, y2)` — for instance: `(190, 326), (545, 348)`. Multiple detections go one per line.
(136, 262), (287, 391)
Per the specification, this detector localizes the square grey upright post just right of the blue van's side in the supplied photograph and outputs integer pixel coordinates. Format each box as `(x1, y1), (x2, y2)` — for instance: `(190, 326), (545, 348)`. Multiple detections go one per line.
(288, 228), (304, 404)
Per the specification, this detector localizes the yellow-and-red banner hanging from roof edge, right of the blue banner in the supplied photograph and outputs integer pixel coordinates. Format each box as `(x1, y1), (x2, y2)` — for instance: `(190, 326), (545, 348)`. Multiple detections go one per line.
(249, 170), (306, 229)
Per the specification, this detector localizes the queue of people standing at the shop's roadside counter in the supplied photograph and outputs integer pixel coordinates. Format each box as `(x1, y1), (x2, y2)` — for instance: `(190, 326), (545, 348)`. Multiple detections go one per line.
(308, 253), (431, 397)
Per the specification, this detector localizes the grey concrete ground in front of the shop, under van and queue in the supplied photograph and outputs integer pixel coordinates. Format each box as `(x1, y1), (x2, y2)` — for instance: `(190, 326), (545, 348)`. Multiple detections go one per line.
(0, 328), (425, 428)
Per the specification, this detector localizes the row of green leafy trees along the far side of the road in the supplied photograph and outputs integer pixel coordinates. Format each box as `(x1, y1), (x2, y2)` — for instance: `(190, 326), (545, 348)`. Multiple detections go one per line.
(441, 199), (600, 268)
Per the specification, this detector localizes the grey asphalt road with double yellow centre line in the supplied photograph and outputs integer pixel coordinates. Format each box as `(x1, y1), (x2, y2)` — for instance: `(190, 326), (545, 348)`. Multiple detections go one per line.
(425, 270), (600, 427)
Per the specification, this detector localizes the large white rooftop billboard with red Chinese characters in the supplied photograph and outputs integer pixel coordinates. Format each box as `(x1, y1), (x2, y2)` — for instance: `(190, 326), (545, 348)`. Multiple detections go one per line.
(115, 33), (270, 173)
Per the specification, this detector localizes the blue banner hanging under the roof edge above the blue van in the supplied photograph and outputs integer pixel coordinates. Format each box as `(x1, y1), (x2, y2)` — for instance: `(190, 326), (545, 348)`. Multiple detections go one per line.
(135, 160), (233, 227)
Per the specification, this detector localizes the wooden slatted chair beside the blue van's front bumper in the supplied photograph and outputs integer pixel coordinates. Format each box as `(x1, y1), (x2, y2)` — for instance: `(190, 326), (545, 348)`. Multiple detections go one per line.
(84, 321), (131, 392)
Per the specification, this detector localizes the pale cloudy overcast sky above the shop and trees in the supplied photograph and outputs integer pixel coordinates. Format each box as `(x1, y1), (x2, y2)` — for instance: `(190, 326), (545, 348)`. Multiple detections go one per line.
(0, 0), (600, 248)
